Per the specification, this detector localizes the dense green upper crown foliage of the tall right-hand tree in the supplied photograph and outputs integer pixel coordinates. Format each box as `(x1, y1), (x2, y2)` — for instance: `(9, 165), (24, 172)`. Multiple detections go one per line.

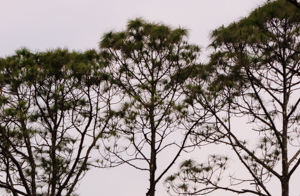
(204, 0), (300, 95)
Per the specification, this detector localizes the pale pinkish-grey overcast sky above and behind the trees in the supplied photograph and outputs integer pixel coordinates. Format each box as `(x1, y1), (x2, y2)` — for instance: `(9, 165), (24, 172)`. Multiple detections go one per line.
(0, 0), (292, 196)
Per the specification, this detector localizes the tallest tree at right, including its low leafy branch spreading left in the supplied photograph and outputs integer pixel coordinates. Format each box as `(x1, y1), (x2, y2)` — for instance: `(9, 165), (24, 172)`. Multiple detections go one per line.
(167, 0), (300, 196)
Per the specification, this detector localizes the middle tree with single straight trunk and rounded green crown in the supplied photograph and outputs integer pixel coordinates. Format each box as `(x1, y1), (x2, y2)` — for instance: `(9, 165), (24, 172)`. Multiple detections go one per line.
(100, 19), (203, 196)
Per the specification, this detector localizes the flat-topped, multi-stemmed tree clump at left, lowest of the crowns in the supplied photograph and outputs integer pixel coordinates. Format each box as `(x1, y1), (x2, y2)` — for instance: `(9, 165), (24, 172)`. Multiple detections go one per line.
(0, 48), (111, 196)
